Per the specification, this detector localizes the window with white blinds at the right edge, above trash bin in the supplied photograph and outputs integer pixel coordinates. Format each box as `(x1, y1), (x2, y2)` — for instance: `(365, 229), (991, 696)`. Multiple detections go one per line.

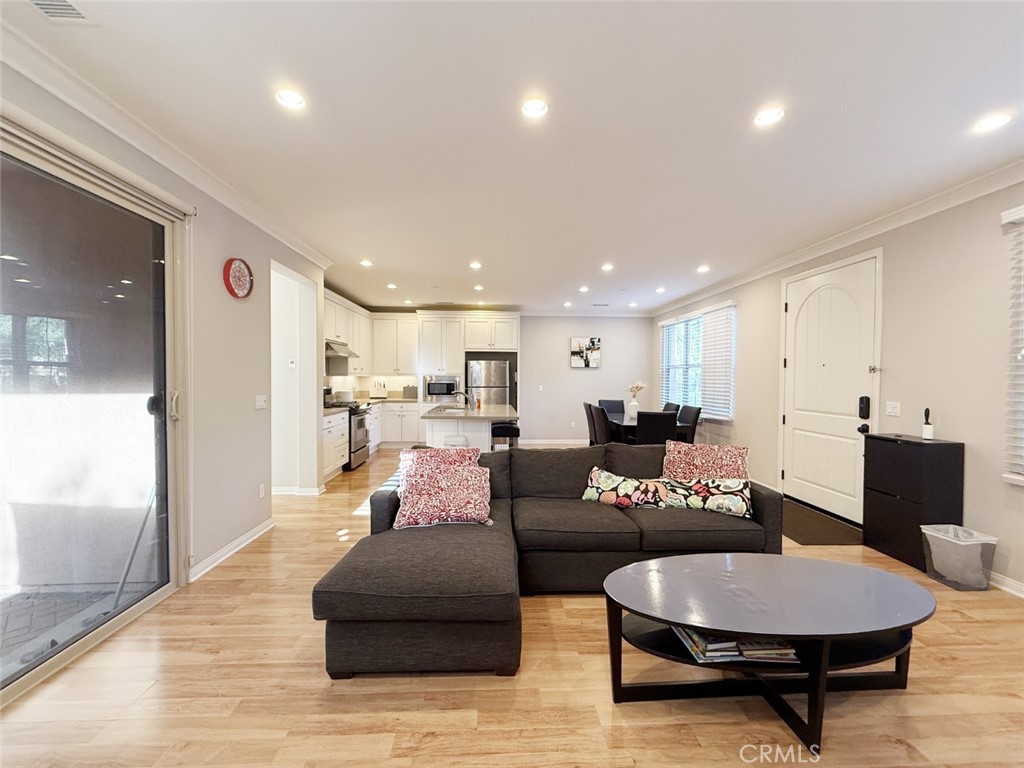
(1002, 206), (1024, 485)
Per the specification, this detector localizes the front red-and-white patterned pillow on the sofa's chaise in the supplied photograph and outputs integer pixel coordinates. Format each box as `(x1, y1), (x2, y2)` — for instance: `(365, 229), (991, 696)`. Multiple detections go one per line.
(394, 466), (494, 529)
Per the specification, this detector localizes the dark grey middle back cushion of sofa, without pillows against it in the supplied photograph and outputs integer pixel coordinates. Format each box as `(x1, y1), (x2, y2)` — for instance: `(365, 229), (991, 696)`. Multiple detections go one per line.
(509, 445), (604, 500)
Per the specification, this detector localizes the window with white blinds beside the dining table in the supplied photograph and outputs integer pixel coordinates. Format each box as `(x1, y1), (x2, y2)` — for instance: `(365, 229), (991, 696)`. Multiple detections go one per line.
(660, 304), (736, 421)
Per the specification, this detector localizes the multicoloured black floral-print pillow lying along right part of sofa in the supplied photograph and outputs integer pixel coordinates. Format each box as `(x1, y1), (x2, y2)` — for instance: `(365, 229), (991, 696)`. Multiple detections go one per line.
(583, 467), (753, 518)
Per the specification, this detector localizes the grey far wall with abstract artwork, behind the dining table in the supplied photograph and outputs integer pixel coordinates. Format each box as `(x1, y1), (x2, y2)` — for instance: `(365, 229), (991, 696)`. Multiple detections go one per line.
(519, 316), (658, 443)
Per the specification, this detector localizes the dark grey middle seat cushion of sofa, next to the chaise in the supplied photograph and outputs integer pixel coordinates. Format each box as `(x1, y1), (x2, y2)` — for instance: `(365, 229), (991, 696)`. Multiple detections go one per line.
(512, 499), (640, 552)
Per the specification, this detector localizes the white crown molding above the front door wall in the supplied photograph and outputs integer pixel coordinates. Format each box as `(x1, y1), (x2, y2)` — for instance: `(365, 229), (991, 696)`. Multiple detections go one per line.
(651, 160), (1024, 317)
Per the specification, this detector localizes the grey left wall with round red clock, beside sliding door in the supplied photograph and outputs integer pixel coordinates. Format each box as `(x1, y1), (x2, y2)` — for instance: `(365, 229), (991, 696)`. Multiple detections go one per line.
(0, 65), (324, 563)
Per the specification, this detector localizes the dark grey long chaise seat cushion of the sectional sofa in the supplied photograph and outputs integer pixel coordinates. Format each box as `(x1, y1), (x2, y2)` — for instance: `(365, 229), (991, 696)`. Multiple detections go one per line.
(313, 499), (519, 626)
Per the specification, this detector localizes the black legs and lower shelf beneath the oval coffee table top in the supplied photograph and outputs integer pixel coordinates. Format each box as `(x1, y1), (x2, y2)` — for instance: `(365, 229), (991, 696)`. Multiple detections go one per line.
(606, 598), (912, 753)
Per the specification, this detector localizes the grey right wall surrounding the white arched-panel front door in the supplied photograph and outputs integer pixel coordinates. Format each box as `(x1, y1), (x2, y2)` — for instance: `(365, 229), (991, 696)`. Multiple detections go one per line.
(649, 184), (1024, 582)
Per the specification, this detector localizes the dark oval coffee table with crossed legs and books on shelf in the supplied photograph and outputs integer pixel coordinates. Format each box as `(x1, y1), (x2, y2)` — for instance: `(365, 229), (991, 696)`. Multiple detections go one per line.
(604, 553), (935, 751)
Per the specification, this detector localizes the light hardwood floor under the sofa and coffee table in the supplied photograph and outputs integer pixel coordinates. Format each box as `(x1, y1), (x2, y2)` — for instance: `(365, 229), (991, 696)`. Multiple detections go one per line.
(0, 451), (1024, 768)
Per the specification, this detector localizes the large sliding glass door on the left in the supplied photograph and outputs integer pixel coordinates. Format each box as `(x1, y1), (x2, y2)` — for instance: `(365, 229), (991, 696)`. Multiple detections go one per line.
(0, 155), (170, 686)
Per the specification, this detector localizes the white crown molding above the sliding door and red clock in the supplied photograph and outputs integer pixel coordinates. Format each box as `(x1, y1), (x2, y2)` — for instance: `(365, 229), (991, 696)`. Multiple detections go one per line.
(0, 18), (335, 269)
